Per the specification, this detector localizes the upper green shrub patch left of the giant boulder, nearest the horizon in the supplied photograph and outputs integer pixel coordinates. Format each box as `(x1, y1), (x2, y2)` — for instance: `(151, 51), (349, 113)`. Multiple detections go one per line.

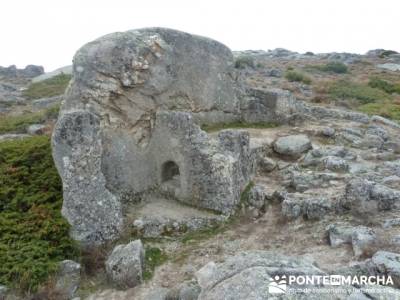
(23, 74), (71, 99)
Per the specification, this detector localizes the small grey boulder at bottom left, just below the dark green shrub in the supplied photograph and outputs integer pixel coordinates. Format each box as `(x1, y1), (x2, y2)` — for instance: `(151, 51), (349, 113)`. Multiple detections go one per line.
(56, 260), (81, 299)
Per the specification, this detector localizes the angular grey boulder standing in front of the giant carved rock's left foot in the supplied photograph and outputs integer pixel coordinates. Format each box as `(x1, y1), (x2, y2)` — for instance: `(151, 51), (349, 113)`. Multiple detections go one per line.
(106, 240), (145, 289)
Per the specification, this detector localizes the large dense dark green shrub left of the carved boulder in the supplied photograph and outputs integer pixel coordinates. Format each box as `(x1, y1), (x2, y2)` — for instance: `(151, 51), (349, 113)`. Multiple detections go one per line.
(0, 136), (77, 291)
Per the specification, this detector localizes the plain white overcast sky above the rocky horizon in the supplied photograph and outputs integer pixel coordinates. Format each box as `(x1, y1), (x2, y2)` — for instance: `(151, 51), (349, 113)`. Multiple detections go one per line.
(0, 0), (400, 71)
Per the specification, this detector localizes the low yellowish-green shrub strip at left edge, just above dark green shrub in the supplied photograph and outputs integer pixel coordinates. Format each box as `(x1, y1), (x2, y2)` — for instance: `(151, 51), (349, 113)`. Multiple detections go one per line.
(0, 105), (60, 134)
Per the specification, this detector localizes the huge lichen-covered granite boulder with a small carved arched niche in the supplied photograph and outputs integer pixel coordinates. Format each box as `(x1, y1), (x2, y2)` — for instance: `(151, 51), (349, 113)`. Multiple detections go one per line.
(52, 28), (254, 244)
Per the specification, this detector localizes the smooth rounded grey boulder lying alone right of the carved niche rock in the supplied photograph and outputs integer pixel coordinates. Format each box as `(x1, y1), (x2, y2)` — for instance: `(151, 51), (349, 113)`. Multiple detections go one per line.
(273, 134), (312, 157)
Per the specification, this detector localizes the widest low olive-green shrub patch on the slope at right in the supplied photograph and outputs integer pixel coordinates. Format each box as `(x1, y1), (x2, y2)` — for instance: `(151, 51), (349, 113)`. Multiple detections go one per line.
(328, 80), (390, 104)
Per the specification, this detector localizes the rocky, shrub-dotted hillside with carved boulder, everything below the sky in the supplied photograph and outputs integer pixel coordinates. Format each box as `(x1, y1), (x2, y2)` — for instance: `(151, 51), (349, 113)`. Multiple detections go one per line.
(0, 29), (400, 300)
